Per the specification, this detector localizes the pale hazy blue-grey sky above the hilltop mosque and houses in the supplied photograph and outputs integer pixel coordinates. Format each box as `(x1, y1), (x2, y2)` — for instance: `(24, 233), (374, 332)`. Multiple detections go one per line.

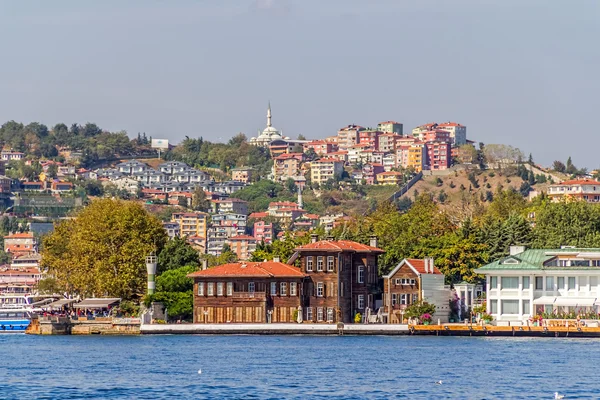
(0, 0), (600, 169)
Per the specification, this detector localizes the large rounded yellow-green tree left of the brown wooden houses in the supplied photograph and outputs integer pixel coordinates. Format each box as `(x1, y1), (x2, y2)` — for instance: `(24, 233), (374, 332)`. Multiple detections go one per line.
(41, 199), (167, 300)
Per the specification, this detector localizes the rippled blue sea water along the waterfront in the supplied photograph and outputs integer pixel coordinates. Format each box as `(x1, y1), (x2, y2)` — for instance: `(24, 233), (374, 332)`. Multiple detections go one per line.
(0, 334), (600, 399)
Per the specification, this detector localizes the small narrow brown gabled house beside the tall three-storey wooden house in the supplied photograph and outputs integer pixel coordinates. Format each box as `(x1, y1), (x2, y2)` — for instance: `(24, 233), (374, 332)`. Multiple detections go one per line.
(383, 258), (444, 324)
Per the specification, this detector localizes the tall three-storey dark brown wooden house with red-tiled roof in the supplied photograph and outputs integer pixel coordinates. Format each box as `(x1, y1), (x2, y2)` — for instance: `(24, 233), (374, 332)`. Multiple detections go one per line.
(288, 235), (384, 323)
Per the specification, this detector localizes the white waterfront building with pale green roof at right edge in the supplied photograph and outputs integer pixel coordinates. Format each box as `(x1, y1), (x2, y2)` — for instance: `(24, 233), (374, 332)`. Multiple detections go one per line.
(475, 246), (600, 321)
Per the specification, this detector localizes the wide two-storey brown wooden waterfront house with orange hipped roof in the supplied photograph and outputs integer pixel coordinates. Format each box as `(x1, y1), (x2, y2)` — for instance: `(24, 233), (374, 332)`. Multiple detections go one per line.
(188, 261), (305, 323)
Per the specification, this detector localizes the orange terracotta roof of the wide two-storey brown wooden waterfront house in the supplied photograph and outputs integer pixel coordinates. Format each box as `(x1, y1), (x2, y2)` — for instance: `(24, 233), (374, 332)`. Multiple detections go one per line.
(188, 261), (304, 278)
